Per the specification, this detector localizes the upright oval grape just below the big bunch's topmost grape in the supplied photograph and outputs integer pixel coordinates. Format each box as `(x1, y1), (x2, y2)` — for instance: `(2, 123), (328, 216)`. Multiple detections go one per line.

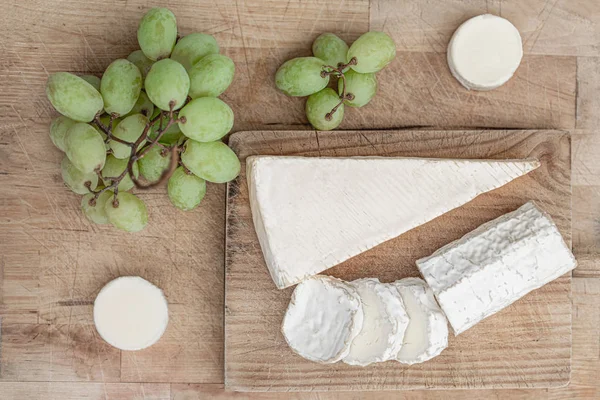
(145, 58), (190, 111)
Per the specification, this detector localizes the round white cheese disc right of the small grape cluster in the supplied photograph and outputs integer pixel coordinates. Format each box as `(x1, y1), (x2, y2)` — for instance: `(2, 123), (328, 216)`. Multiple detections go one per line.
(448, 14), (523, 90)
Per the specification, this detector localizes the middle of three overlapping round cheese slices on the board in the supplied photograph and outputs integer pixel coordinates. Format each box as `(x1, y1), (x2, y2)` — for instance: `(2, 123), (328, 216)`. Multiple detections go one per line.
(344, 278), (408, 366)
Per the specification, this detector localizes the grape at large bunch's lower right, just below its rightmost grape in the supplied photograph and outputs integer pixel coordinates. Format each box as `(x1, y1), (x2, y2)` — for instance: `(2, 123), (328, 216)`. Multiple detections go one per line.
(167, 167), (206, 211)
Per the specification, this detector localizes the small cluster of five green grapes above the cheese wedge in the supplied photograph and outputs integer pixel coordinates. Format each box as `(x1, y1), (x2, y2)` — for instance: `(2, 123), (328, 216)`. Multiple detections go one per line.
(275, 32), (396, 131)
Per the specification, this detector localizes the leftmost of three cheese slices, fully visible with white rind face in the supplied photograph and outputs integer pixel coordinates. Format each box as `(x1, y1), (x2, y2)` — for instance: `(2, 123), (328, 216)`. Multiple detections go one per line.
(281, 275), (363, 363)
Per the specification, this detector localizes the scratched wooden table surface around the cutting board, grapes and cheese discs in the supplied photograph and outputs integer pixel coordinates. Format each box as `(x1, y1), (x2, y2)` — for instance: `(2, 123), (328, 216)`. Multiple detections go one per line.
(0, 0), (600, 400)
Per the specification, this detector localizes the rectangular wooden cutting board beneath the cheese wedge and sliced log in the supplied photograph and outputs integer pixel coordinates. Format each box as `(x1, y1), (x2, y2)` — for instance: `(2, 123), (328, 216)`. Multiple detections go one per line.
(225, 130), (571, 391)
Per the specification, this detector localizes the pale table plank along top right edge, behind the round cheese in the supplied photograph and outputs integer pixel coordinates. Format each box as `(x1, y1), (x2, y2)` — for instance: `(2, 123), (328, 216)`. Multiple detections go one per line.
(371, 0), (600, 56)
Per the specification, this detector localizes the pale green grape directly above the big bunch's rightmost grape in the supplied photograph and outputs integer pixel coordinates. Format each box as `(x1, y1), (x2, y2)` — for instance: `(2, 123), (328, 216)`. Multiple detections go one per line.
(179, 97), (233, 142)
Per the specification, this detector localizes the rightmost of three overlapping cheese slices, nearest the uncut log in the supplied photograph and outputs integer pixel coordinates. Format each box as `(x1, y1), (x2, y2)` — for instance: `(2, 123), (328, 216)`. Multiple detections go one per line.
(394, 278), (448, 364)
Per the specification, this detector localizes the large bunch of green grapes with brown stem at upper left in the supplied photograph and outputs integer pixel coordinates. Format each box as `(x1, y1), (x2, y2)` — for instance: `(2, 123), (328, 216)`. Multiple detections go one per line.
(46, 8), (240, 232)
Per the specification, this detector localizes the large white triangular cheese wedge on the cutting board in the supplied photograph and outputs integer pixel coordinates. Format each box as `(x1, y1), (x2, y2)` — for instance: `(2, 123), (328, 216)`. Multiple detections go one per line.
(246, 156), (539, 289)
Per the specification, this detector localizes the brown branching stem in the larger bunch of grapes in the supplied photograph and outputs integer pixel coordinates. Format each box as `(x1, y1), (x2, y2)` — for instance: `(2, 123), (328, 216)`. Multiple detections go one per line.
(85, 98), (189, 207)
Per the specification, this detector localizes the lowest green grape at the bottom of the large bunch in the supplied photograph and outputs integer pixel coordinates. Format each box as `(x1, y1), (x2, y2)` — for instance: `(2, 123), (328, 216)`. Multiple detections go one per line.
(104, 192), (148, 232)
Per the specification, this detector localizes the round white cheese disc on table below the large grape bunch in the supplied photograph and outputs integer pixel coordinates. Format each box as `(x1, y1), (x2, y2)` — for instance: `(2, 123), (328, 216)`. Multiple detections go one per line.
(94, 276), (169, 350)
